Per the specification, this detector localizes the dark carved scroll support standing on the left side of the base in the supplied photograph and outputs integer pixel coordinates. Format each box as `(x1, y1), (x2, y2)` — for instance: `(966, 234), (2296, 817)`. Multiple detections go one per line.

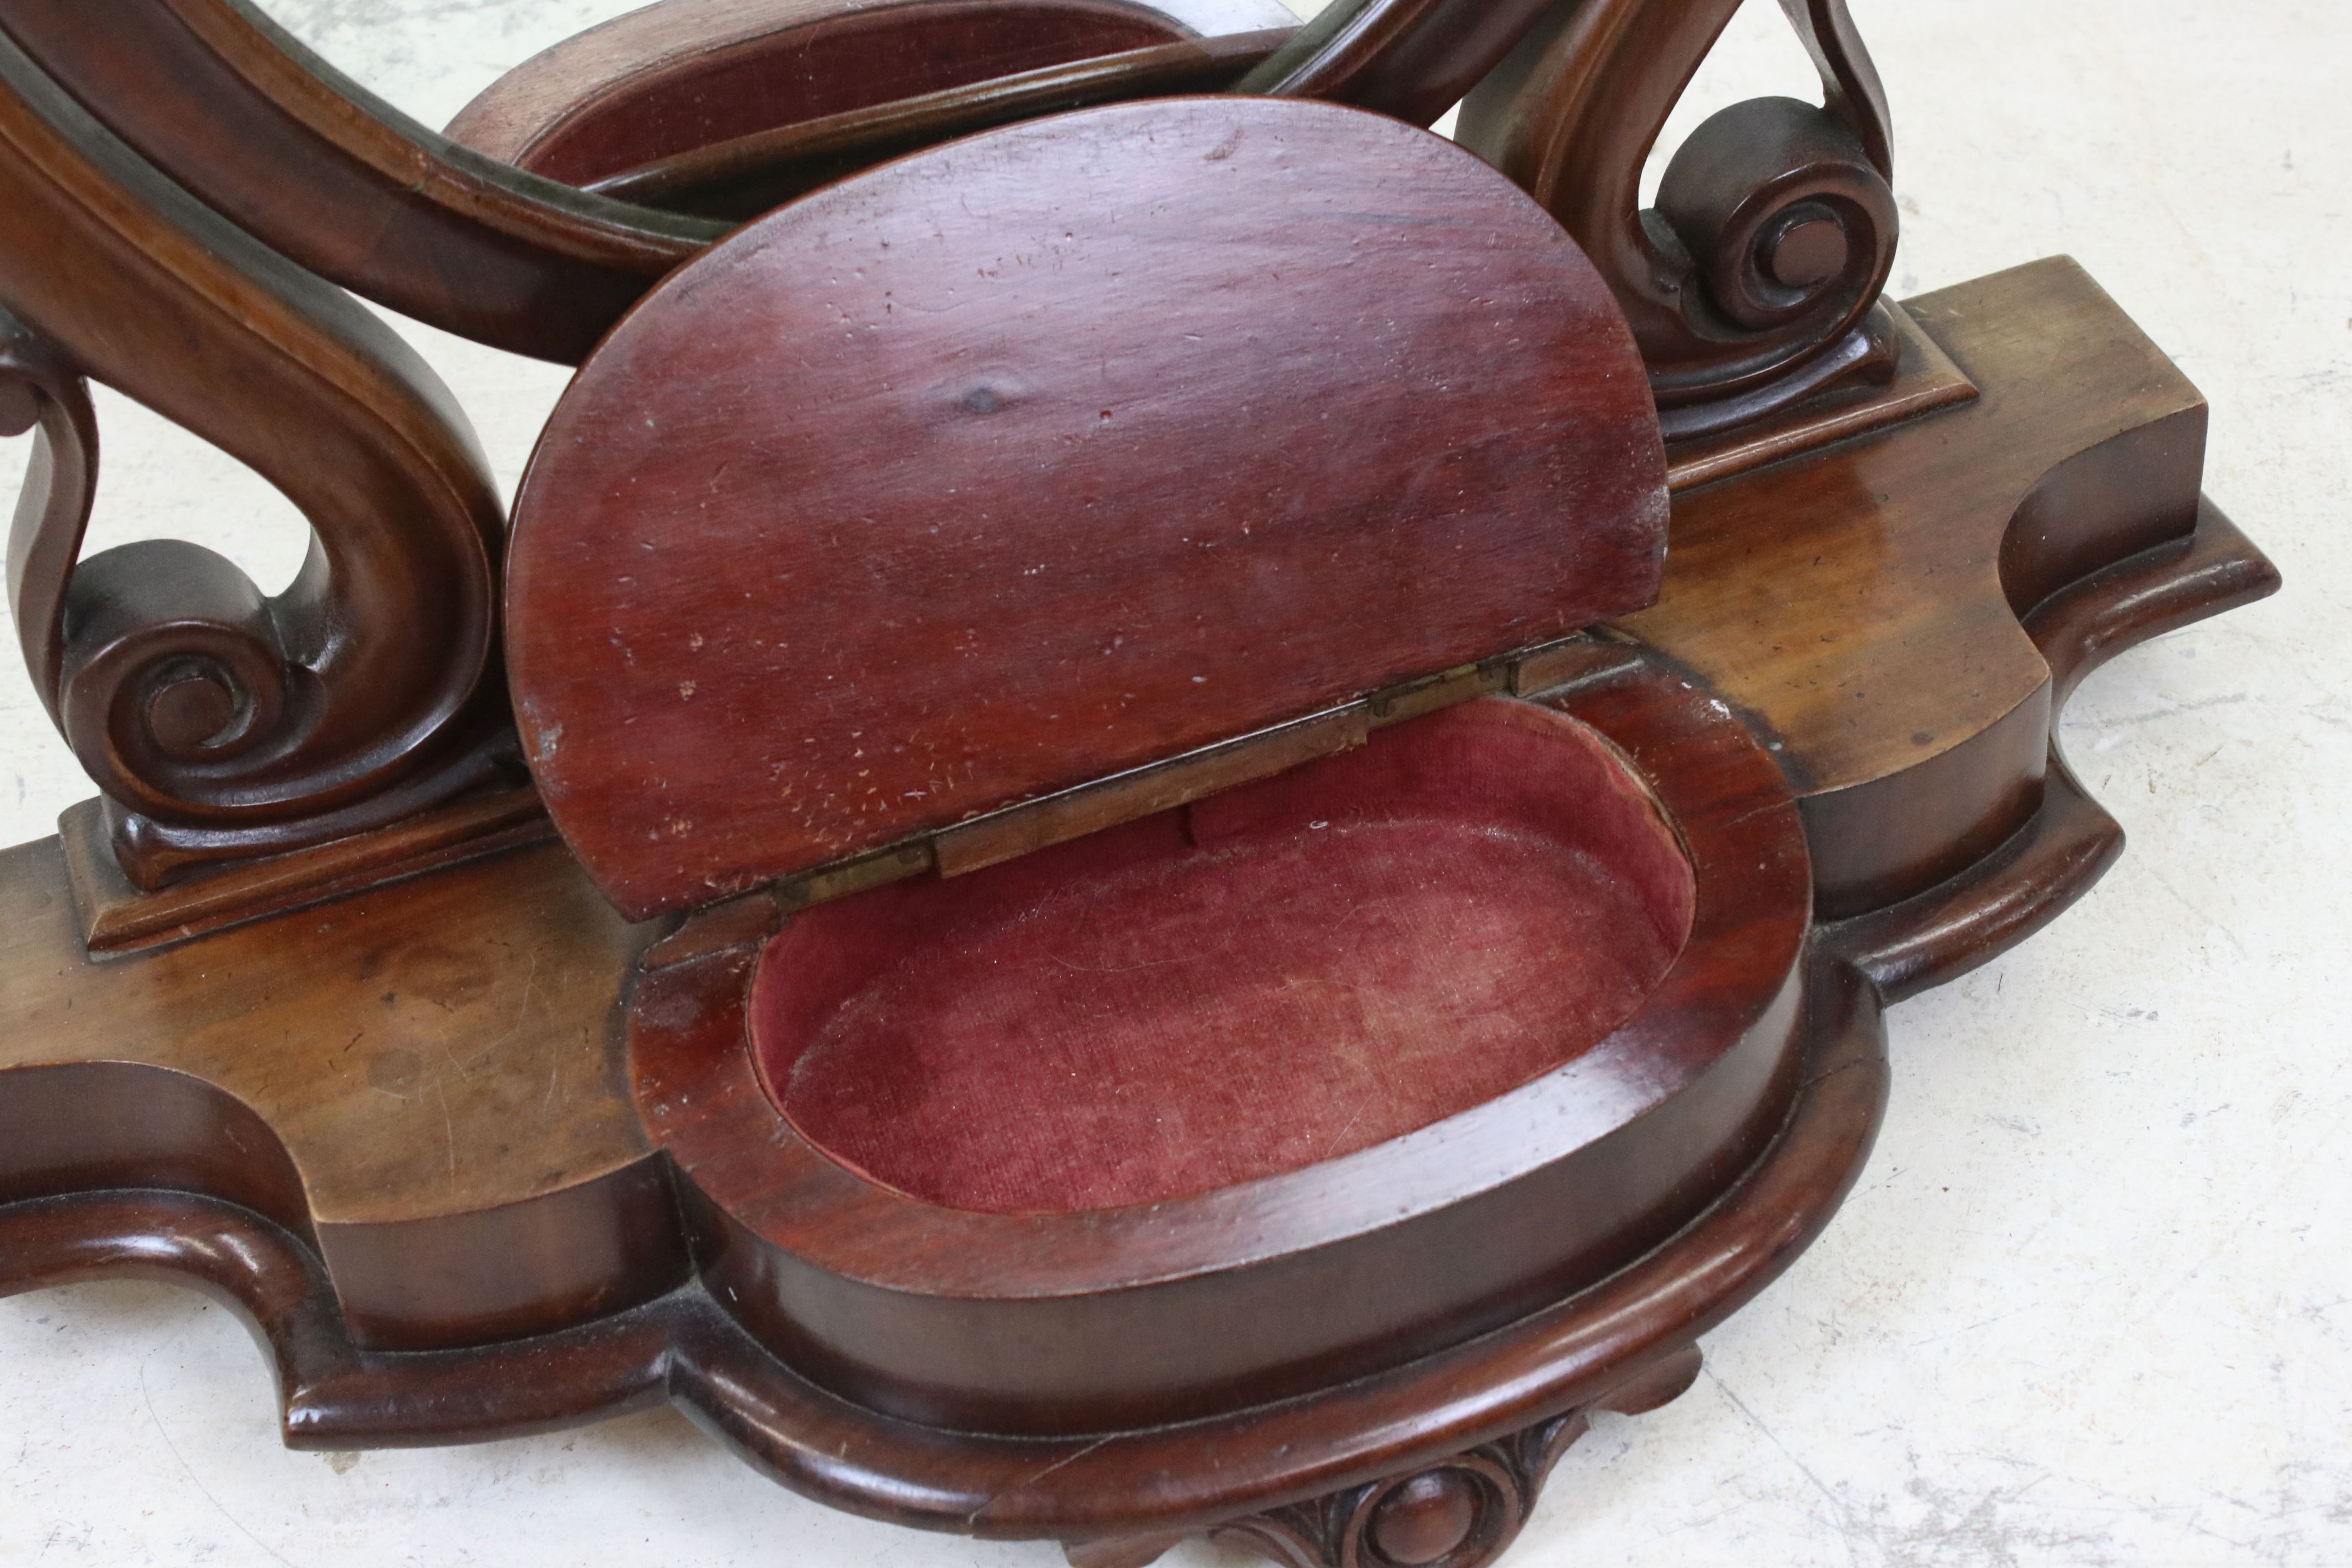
(0, 40), (504, 886)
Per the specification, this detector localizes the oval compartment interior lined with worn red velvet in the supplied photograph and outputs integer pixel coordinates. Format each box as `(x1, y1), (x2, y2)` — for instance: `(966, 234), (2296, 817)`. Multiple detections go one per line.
(750, 701), (1693, 1213)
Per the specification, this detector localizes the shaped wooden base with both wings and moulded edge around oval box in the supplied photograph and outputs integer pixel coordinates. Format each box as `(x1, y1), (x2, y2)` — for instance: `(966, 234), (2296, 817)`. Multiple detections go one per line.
(0, 263), (2277, 1568)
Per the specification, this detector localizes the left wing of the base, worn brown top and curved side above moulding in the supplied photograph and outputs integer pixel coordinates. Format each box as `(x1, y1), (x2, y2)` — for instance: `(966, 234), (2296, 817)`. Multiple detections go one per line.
(0, 839), (682, 1345)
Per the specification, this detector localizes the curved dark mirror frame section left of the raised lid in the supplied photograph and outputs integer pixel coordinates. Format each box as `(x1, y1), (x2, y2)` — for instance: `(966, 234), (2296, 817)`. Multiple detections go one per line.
(0, 0), (724, 364)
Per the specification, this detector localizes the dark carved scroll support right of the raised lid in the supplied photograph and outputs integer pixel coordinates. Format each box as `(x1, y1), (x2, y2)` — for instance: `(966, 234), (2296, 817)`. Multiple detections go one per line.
(1461, 0), (1898, 440)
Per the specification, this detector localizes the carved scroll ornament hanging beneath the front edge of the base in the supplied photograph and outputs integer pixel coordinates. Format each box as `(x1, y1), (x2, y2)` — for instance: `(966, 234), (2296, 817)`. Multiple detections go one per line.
(1066, 1345), (1700, 1568)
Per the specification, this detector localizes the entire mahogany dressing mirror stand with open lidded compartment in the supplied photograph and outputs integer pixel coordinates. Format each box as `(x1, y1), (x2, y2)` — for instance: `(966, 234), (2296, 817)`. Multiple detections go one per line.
(0, 0), (2277, 1568)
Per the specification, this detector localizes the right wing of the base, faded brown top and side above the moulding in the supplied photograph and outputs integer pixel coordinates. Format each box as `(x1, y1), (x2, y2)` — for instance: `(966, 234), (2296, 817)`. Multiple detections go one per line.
(1623, 261), (2204, 917)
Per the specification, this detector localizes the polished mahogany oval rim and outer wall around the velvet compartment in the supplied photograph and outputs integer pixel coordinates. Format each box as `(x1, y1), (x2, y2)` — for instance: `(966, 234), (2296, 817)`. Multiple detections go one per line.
(628, 637), (1811, 1432)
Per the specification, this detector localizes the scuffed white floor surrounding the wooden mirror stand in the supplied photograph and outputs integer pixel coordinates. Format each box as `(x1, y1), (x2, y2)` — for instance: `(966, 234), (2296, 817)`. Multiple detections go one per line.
(0, 0), (2352, 1568)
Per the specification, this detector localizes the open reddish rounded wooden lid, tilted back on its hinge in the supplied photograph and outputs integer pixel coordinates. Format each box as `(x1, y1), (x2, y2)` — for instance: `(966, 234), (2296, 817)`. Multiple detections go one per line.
(508, 99), (1665, 917)
